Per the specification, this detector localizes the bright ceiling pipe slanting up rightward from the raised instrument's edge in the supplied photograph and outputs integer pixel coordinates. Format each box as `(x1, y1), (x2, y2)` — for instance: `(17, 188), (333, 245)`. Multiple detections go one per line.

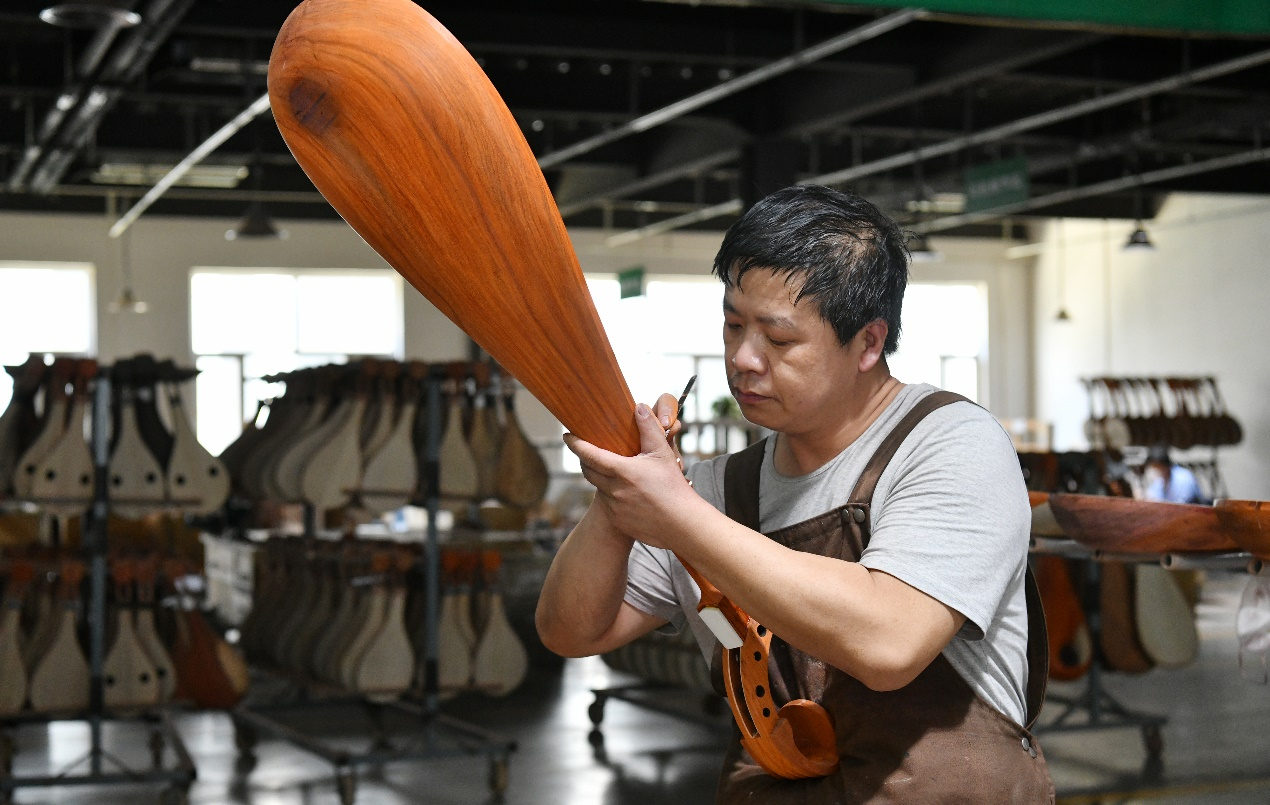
(538, 9), (925, 170)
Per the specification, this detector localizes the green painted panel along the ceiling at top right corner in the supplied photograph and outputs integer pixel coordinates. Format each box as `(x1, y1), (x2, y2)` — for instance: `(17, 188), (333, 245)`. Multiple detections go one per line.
(829, 0), (1270, 36)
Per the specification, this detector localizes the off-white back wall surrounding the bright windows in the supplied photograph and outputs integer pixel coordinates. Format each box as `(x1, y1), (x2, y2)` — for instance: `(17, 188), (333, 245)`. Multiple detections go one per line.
(0, 213), (1033, 454)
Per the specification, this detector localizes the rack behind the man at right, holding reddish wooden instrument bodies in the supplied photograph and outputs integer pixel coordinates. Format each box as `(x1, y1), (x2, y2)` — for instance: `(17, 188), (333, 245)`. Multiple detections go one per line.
(1029, 477), (1270, 771)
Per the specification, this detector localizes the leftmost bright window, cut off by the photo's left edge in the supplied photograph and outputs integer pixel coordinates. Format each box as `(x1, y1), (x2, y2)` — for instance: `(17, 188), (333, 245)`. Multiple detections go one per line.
(0, 262), (97, 410)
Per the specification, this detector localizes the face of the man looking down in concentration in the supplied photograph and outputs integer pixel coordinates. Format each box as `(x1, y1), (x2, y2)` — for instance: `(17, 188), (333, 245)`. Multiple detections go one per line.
(723, 269), (860, 434)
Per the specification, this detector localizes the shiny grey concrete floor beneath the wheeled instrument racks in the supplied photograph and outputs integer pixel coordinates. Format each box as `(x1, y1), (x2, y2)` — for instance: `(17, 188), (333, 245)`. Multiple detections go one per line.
(2, 575), (1270, 805)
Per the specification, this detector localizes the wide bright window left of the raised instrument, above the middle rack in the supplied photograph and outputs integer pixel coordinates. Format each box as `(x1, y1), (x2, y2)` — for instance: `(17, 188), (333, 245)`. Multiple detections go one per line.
(189, 268), (403, 453)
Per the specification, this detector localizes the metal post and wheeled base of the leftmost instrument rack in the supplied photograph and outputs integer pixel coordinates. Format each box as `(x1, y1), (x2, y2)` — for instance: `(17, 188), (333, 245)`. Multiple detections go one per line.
(0, 373), (197, 805)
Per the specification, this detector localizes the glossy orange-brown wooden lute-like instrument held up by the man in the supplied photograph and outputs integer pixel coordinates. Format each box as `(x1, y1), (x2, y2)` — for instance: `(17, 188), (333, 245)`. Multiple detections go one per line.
(269, 0), (837, 776)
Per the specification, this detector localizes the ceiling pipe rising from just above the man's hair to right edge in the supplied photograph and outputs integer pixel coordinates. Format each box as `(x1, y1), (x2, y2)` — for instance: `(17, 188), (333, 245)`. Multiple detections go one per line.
(799, 50), (1270, 184)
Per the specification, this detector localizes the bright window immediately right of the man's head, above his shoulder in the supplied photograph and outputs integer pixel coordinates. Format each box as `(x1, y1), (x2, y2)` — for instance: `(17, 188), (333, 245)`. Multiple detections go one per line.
(888, 283), (988, 401)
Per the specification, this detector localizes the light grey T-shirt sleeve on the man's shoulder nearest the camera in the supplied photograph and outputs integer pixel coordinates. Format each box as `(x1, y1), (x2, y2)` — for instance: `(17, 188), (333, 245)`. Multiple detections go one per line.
(860, 403), (1031, 640)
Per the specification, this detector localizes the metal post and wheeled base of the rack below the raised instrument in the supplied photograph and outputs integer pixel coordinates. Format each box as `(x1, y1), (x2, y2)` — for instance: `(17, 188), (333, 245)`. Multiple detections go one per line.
(230, 373), (516, 805)
